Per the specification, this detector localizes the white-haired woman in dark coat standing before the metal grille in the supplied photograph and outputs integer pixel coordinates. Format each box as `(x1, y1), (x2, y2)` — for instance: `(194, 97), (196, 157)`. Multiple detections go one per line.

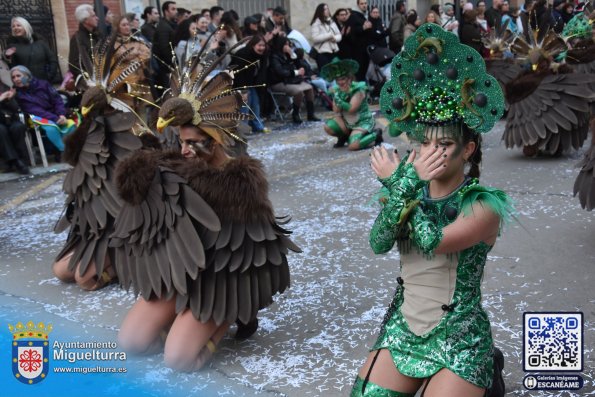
(4, 17), (60, 83)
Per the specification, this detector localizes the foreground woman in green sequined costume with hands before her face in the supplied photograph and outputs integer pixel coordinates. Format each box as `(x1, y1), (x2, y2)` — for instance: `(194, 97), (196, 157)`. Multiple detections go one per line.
(351, 24), (512, 397)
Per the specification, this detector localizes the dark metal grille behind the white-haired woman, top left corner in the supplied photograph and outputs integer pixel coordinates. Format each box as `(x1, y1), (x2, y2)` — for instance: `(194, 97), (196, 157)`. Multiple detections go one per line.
(0, 0), (58, 53)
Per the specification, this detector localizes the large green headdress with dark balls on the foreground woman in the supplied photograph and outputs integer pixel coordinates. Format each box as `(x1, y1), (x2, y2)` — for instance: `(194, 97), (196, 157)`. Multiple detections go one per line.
(380, 23), (504, 140)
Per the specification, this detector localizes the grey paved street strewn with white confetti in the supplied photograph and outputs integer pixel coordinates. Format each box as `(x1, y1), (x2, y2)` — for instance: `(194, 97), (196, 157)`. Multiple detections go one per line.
(0, 116), (595, 397)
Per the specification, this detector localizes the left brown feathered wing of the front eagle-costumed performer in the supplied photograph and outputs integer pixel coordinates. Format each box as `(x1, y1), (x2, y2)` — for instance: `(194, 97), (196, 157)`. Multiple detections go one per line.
(110, 153), (221, 300)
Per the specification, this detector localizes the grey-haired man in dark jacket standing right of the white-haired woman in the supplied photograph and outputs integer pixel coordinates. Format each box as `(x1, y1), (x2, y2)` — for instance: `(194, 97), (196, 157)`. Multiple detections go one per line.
(68, 4), (101, 79)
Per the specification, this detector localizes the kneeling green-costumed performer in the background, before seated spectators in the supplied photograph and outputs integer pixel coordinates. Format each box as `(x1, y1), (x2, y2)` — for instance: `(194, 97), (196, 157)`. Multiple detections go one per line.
(321, 58), (382, 150)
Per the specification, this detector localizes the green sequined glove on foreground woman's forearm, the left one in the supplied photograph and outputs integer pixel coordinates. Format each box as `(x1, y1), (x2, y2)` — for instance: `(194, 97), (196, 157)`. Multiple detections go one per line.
(370, 163), (426, 254)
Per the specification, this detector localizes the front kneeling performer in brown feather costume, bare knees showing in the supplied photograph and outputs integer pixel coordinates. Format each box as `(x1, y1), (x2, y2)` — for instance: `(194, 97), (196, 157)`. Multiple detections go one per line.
(112, 32), (300, 371)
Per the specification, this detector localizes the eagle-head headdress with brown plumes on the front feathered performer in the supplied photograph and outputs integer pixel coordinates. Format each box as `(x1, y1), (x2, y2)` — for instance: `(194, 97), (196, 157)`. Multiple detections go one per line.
(157, 28), (251, 146)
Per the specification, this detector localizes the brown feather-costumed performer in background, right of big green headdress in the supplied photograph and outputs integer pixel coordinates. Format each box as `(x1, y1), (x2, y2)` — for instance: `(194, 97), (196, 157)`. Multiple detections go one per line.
(502, 24), (595, 156)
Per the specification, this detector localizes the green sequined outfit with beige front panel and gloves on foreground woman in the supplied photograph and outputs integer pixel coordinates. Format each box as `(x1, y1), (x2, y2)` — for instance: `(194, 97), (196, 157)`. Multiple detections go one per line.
(370, 169), (512, 388)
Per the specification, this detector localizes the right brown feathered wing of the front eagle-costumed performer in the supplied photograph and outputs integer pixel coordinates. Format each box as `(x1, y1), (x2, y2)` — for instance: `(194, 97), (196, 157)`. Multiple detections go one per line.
(176, 158), (301, 324)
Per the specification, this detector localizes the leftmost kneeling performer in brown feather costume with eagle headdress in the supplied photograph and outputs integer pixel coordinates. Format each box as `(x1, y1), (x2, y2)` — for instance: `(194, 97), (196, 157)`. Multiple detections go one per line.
(52, 33), (154, 290)
